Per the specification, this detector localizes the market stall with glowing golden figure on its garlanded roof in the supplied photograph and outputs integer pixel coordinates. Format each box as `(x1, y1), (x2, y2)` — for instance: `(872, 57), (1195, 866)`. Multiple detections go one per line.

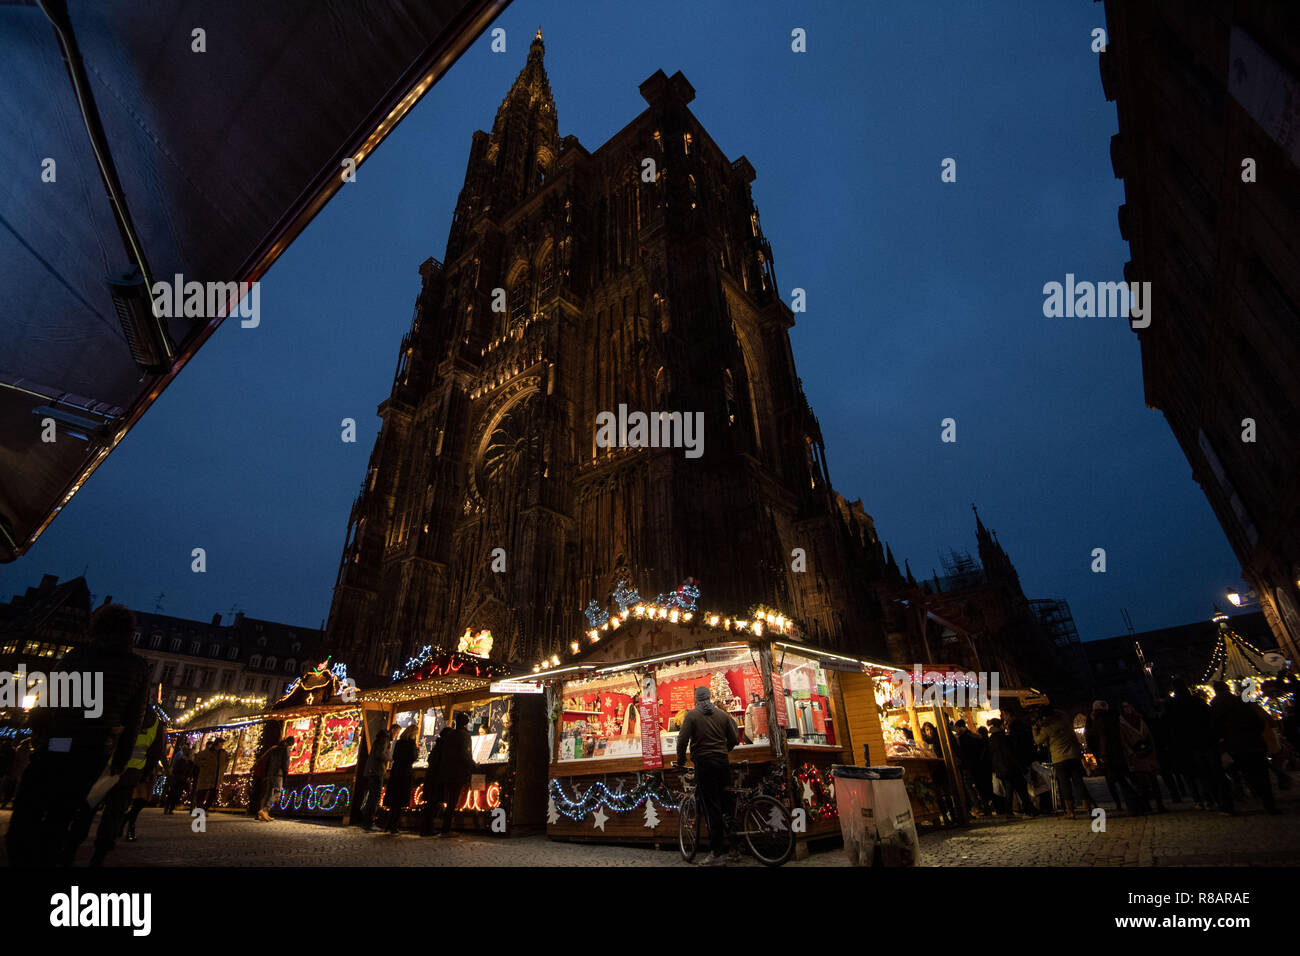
(358, 631), (546, 834)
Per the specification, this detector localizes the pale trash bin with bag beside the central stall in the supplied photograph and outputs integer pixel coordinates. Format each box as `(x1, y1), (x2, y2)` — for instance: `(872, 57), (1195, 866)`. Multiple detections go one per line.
(831, 763), (920, 866)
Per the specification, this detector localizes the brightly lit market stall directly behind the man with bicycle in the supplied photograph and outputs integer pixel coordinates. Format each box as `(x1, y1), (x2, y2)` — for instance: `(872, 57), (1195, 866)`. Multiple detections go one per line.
(519, 585), (899, 843)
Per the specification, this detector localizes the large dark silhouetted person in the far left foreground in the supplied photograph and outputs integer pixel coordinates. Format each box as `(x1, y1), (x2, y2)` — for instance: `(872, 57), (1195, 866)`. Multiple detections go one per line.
(5, 605), (150, 866)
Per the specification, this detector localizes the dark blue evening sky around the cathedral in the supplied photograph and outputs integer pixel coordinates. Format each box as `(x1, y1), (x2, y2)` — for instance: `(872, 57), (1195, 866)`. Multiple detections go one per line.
(0, 0), (1240, 640)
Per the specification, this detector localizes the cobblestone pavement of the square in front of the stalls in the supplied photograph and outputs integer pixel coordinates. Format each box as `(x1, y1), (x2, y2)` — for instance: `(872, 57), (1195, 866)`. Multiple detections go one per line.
(0, 790), (1300, 866)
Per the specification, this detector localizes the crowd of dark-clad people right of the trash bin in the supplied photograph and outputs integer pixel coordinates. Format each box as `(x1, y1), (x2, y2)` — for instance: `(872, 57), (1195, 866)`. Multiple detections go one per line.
(920, 682), (1300, 822)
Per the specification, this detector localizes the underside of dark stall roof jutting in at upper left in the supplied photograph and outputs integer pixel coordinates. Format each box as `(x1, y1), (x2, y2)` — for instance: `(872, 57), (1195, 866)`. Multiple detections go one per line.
(0, 0), (510, 561)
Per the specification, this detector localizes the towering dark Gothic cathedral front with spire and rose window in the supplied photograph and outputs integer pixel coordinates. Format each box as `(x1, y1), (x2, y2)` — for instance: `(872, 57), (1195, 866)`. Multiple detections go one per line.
(328, 31), (885, 672)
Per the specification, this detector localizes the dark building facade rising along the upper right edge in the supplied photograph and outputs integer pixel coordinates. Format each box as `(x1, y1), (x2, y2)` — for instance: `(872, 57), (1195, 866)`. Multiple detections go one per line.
(1101, 0), (1300, 659)
